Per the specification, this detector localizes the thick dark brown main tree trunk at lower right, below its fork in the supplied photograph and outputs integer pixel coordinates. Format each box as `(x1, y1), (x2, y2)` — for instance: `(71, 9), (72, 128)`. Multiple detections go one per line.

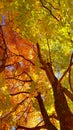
(52, 78), (73, 130)
